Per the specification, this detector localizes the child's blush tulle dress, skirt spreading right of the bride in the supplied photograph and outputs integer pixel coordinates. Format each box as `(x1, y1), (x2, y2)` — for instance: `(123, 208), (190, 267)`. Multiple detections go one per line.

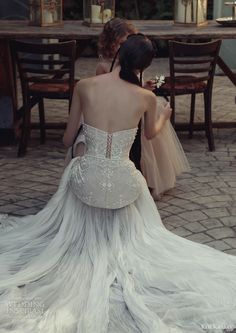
(141, 97), (190, 199)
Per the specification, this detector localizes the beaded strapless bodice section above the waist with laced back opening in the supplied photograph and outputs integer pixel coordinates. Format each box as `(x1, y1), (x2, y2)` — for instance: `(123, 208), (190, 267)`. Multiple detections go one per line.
(83, 123), (137, 159)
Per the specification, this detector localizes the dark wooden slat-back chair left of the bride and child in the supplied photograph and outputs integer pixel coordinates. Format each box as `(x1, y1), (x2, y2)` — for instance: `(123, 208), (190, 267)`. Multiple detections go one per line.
(11, 41), (76, 156)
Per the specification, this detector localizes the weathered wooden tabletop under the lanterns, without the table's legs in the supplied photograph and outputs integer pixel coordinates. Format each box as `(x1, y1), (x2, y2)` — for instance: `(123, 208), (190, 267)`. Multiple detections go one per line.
(0, 20), (236, 40)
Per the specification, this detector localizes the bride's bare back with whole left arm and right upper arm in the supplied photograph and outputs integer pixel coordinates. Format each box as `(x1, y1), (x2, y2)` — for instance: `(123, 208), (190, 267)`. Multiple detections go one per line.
(63, 68), (166, 146)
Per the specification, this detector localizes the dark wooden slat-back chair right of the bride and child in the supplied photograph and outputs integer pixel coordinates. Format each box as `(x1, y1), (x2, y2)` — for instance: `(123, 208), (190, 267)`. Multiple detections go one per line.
(157, 40), (221, 151)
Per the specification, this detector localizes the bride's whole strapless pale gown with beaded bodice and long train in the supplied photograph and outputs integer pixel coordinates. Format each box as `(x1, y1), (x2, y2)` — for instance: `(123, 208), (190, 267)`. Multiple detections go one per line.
(0, 124), (236, 333)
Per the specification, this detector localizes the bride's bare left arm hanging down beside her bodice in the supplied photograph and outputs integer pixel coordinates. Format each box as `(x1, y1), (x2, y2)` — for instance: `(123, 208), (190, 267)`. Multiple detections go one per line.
(63, 81), (81, 147)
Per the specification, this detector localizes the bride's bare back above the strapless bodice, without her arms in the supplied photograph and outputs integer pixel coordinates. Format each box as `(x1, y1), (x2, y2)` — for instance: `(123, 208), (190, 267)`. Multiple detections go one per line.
(81, 70), (150, 132)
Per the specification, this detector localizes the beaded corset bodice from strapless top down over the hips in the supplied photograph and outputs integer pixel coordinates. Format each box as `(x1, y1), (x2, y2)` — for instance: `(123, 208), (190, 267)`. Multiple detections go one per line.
(67, 124), (143, 209)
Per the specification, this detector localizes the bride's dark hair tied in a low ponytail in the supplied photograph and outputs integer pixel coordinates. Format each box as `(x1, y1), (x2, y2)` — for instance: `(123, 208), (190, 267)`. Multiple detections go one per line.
(118, 34), (155, 86)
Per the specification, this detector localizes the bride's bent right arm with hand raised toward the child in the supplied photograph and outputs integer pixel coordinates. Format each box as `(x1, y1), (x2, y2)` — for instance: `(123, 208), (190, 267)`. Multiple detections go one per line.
(144, 94), (172, 140)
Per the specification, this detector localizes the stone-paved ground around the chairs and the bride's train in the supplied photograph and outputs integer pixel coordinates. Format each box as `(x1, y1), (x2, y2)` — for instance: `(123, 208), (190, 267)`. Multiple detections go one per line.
(0, 59), (236, 255)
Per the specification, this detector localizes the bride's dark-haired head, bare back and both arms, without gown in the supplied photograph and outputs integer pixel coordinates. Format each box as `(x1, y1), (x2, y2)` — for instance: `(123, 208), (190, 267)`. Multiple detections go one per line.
(63, 35), (171, 146)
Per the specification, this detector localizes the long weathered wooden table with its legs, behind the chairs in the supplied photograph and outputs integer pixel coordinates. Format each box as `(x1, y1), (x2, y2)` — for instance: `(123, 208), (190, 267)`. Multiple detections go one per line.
(0, 20), (236, 142)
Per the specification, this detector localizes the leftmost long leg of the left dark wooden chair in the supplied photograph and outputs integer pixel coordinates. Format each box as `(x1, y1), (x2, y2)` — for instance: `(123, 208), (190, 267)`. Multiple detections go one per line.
(17, 105), (30, 157)
